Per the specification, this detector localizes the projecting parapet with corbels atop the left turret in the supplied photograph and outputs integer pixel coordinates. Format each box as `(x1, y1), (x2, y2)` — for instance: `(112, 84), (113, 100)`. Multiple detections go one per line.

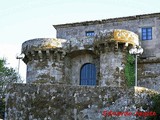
(22, 38), (65, 64)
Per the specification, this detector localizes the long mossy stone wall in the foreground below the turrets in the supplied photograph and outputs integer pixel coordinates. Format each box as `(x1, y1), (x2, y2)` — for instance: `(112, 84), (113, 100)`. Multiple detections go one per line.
(5, 84), (158, 120)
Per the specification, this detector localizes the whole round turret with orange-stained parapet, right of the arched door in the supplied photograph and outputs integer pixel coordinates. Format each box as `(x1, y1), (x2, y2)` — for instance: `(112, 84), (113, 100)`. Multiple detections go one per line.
(94, 29), (139, 87)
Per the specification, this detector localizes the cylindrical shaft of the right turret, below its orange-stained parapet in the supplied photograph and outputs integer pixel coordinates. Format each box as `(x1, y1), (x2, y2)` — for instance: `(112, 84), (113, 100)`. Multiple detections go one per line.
(99, 52), (125, 87)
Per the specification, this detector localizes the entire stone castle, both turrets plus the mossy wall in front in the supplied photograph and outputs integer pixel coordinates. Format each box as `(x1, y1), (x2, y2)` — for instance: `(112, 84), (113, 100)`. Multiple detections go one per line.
(5, 13), (160, 120)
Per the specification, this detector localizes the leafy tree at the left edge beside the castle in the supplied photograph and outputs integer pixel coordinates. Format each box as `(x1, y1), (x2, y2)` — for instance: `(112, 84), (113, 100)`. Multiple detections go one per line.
(0, 59), (22, 118)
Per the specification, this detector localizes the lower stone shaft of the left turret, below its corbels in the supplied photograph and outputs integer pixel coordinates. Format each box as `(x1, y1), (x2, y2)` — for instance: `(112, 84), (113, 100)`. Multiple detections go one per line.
(27, 59), (64, 84)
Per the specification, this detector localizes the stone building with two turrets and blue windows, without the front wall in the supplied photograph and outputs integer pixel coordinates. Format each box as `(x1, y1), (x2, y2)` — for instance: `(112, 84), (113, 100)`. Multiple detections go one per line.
(22, 13), (160, 89)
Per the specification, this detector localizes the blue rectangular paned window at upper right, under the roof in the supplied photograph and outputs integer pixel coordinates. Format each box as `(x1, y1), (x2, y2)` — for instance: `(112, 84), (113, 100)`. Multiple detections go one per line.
(142, 27), (152, 40)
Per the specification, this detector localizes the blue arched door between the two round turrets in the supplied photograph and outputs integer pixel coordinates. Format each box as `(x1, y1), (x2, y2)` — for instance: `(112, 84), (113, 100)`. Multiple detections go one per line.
(80, 63), (96, 85)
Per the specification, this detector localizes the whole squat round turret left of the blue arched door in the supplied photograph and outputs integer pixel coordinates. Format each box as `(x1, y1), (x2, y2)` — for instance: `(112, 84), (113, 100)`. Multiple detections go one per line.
(22, 38), (65, 83)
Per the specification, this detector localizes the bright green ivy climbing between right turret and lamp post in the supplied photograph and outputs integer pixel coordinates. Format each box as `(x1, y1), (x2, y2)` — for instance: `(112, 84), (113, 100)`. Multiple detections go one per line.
(124, 53), (135, 87)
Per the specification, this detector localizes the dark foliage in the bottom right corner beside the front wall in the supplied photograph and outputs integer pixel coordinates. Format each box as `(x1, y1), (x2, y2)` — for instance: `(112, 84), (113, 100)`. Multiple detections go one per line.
(147, 94), (160, 120)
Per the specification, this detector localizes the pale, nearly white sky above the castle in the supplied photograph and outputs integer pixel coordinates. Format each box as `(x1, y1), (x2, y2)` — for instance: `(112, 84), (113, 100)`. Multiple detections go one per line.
(0, 0), (160, 80)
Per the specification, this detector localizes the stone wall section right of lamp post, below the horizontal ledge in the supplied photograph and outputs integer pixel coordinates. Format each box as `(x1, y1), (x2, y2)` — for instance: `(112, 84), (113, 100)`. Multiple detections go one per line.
(138, 59), (160, 91)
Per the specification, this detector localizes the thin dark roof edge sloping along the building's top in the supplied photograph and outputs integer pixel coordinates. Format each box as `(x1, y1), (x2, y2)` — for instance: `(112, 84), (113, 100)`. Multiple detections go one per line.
(53, 12), (160, 29)
